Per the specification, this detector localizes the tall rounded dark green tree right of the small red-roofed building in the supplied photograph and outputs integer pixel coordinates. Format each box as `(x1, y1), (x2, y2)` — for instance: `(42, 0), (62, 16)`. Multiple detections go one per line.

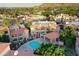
(60, 26), (76, 48)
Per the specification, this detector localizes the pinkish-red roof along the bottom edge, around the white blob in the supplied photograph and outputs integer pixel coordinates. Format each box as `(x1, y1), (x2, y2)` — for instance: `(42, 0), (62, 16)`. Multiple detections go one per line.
(7, 50), (34, 56)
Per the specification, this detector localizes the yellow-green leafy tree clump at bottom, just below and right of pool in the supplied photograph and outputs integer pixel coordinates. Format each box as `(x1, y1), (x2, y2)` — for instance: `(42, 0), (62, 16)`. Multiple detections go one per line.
(34, 43), (64, 56)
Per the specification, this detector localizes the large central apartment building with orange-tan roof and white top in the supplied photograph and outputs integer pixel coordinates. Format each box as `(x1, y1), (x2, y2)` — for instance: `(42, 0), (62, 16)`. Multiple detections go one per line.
(31, 21), (58, 37)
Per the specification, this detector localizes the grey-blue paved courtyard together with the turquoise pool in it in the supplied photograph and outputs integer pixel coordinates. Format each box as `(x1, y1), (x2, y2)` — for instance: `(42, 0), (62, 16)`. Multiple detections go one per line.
(18, 38), (44, 52)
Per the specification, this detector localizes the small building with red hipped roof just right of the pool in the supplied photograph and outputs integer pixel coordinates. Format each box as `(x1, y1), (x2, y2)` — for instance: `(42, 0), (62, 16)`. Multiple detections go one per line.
(43, 31), (64, 46)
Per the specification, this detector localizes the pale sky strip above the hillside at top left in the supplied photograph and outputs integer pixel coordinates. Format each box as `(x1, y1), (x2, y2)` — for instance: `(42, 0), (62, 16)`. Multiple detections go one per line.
(0, 3), (42, 7)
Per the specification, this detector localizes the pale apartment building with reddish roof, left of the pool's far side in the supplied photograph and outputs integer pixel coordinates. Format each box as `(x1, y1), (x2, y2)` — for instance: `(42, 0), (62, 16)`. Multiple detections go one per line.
(10, 24), (29, 42)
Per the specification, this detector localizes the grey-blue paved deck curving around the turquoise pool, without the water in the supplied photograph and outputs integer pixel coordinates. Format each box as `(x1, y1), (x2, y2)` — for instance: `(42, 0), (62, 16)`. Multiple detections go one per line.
(18, 38), (44, 52)
